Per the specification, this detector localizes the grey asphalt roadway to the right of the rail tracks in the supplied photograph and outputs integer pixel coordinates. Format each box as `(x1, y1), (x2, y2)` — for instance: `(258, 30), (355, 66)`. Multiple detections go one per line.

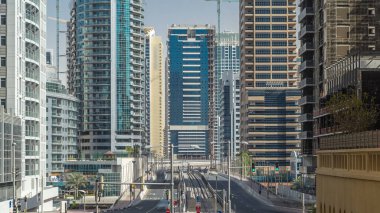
(206, 175), (299, 213)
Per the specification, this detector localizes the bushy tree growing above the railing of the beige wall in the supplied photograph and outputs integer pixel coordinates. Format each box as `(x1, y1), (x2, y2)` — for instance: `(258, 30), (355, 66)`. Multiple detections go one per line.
(327, 93), (379, 133)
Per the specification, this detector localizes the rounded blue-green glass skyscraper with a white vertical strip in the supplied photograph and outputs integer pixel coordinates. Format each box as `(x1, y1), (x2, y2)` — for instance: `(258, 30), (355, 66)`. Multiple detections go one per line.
(67, 0), (145, 158)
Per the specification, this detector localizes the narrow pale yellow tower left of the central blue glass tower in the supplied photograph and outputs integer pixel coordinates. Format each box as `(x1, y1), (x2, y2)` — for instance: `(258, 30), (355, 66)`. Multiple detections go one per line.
(145, 28), (166, 156)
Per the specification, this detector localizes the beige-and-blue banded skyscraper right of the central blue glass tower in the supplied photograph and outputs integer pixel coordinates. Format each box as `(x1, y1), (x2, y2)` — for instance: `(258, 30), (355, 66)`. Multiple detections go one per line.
(240, 0), (300, 170)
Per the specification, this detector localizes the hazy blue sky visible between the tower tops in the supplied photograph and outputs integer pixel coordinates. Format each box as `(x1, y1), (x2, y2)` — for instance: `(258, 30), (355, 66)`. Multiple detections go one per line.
(47, 0), (239, 71)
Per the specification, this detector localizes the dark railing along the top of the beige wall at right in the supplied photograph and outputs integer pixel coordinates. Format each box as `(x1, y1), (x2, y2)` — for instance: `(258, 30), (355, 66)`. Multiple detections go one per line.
(318, 130), (380, 150)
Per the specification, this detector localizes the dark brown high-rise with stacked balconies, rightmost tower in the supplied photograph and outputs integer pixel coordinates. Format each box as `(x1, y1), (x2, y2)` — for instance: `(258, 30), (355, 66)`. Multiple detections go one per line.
(298, 0), (380, 188)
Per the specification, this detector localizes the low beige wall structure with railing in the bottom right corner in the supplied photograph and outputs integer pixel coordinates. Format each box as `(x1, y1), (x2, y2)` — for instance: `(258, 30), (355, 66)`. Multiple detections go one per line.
(316, 131), (380, 213)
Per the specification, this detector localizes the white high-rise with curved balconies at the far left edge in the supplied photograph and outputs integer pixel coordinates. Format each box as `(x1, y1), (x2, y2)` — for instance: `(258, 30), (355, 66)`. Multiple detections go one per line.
(0, 0), (58, 211)
